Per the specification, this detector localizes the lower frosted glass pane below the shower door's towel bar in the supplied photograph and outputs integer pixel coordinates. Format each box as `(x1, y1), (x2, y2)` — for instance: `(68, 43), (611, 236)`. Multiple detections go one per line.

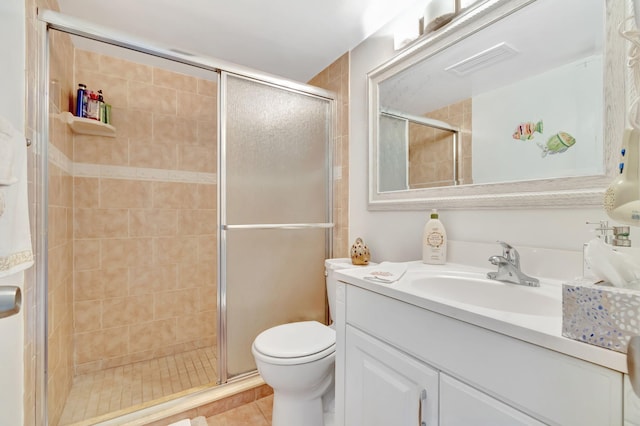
(227, 229), (326, 377)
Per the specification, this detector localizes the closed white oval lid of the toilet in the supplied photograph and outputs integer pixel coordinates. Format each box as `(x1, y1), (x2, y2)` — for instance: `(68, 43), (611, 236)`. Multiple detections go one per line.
(253, 321), (336, 358)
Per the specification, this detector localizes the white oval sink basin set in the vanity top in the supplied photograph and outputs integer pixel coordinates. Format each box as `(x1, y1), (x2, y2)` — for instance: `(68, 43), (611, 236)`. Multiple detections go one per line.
(406, 272), (562, 317)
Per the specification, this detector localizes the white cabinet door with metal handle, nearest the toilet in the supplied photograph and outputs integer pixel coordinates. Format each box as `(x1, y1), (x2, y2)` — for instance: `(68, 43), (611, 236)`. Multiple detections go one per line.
(345, 326), (438, 426)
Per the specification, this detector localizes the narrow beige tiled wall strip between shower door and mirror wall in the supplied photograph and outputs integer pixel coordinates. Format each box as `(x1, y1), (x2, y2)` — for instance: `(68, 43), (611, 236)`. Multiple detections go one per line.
(308, 53), (351, 257)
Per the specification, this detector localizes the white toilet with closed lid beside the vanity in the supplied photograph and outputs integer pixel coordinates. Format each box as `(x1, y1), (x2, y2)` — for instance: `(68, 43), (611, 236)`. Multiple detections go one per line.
(251, 258), (355, 426)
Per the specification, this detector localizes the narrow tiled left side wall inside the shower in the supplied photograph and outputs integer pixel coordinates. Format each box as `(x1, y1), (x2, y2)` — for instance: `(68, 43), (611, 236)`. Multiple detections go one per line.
(47, 25), (74, 424)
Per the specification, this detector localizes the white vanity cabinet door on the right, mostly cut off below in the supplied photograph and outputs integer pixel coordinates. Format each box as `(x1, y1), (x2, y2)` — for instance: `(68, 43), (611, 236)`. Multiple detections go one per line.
(440, 373), (544, 426)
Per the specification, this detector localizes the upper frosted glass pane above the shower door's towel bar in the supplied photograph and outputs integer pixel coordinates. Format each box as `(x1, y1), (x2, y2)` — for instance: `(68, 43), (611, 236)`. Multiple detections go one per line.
(226, 76), (330, 224)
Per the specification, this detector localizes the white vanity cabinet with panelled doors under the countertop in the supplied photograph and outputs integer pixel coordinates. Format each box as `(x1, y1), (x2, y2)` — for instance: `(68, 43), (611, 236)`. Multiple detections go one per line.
(336, 285), (623, 426)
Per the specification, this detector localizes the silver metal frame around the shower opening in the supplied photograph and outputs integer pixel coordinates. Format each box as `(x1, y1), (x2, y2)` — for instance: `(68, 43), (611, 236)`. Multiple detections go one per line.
(35, 9), (337, 424)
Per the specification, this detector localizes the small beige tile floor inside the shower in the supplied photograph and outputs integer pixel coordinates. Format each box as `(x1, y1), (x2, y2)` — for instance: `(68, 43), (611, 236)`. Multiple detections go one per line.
(59, 347), (218, 425)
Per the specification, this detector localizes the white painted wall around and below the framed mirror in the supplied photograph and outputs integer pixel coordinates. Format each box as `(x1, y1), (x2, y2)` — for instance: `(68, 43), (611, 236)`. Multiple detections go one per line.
(349, 1), (608, 262)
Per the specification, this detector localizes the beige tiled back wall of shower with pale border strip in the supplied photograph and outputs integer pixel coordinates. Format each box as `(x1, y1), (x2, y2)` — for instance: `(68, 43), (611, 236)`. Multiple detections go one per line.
(73, 50), (217, 374)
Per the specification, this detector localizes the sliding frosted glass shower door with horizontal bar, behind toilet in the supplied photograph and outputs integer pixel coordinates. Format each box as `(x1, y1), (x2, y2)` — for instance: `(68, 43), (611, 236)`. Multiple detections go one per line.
(218, 72), (334, 382)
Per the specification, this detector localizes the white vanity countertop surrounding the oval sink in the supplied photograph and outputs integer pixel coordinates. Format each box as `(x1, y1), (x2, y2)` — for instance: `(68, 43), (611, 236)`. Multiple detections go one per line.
(336, 261), (627, 373)
